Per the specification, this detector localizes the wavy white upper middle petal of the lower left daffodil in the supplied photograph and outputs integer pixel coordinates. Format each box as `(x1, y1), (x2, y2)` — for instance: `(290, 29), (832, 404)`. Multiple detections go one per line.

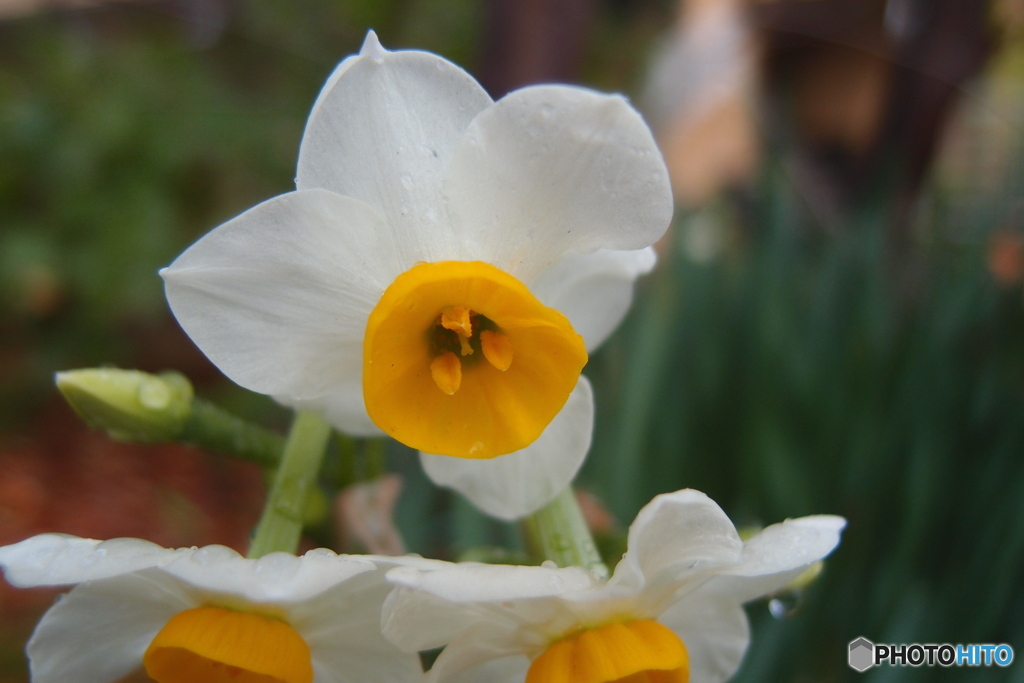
(161, 546), (376, 606)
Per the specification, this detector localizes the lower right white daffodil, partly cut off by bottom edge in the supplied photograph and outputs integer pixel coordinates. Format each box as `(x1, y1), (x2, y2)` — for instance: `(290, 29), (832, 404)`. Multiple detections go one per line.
(384, 490), (846, 683)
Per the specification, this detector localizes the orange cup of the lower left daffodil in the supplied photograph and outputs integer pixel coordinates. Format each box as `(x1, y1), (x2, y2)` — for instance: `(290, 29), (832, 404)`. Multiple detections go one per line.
(142, 607), (313, 683)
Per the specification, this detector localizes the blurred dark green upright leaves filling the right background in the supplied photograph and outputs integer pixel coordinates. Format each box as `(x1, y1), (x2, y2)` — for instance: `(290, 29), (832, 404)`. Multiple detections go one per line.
(583, 165), (1024, 681)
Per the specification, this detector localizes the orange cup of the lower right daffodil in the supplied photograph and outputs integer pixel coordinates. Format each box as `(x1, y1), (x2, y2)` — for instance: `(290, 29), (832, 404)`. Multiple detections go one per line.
(526, 620), (690, 683)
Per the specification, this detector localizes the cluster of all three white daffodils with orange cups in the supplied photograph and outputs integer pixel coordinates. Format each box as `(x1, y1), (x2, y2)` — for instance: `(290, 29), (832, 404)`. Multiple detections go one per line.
(0, 33), (845, 683)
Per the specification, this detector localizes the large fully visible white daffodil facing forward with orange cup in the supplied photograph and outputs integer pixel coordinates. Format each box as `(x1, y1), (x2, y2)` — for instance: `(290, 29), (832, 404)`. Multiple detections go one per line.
(161, 32), (672, 518)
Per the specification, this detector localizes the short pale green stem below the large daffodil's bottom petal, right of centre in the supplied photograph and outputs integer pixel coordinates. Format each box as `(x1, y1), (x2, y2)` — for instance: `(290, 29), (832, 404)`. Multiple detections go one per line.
(522, 486), (608, 577)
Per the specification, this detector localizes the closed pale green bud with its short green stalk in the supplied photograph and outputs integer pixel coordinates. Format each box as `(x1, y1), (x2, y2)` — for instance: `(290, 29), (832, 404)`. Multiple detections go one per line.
(55, 368), (285, 467)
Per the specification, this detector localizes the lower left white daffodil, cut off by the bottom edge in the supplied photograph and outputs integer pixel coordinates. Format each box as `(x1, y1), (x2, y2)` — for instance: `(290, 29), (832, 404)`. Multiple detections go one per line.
(0, 533), (429, 683)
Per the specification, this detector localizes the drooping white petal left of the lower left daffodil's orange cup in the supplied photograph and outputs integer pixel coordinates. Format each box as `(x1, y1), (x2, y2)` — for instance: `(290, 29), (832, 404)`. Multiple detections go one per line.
(27, 569), (192, 683)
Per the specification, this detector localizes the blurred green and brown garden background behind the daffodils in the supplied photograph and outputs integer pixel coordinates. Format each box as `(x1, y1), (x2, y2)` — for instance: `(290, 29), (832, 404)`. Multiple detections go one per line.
(0, 0), (1024, 683)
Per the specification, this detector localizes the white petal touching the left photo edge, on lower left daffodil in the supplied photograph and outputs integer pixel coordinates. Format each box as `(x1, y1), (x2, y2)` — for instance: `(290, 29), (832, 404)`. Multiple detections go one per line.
(0, 533), (182, 588)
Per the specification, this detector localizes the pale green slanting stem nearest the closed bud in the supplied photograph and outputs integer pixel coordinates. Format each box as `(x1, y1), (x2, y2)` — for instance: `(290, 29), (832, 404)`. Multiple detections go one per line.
(248, 412), (331, 557)
